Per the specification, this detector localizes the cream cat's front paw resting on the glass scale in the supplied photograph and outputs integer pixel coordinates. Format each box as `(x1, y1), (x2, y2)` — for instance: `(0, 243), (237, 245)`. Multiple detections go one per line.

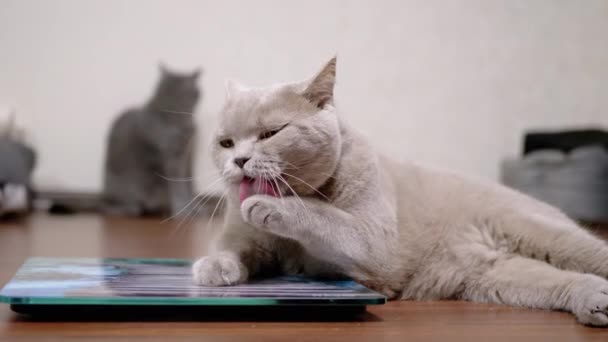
(192, 254), (248, 286)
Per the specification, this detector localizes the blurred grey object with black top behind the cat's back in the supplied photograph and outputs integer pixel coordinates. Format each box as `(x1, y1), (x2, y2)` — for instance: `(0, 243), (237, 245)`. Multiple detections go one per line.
(502, 129), (608, 223)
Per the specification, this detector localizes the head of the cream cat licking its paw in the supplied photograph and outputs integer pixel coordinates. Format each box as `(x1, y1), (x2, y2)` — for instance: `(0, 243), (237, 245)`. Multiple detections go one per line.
(212, 58), (342, 195)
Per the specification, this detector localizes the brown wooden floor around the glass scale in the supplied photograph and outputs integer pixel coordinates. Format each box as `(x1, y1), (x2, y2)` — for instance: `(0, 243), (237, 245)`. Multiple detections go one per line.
(0, 214), (608, 342)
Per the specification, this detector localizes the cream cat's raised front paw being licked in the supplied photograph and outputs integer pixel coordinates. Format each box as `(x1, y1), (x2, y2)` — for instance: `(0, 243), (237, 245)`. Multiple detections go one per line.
(241, 195), (284, 232)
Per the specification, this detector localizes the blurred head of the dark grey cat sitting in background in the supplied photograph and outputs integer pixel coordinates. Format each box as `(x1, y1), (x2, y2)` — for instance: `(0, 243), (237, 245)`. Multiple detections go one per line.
(151, 63), (201, 113)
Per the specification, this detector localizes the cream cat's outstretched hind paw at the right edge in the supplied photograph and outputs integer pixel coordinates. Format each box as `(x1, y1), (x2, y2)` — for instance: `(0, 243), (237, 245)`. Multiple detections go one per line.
(572, 276), (608, 327)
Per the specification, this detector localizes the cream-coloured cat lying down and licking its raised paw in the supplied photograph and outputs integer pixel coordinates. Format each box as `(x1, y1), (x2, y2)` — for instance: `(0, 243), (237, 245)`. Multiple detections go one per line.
(193, 59), (608, 326)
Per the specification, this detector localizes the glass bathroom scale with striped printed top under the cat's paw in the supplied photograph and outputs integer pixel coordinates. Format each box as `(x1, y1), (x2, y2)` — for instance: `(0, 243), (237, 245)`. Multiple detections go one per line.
(0, 258), (386, 314)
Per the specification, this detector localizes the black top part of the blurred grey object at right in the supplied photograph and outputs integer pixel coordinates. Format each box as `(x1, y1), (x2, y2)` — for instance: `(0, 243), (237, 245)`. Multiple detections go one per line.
(523, 129), (608, 155)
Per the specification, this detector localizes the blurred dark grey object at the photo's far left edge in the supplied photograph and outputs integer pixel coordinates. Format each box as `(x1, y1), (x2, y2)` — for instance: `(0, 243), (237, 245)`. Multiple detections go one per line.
(0, 113), (36, 219)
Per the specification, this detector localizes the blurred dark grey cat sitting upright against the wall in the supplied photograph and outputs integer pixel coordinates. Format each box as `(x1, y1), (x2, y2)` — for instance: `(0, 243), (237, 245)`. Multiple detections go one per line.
(103, 64), (201, 216)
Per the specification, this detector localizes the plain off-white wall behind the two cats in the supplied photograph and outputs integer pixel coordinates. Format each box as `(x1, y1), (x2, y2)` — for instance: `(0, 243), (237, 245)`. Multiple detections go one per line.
(0, 0), (608, 190)
